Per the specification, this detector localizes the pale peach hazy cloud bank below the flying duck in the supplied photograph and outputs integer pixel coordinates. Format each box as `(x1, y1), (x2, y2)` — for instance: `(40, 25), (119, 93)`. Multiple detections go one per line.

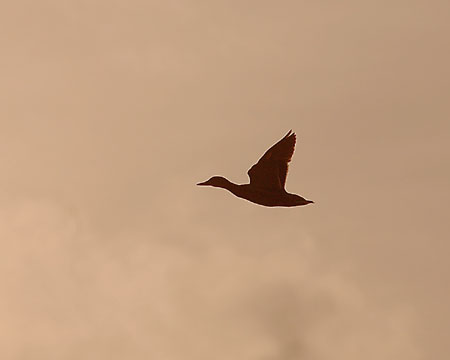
(0, 200), (420, 360)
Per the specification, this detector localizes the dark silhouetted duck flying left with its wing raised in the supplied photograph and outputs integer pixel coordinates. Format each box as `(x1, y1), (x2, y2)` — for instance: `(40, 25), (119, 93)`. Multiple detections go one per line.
(197, 130), (314, 207)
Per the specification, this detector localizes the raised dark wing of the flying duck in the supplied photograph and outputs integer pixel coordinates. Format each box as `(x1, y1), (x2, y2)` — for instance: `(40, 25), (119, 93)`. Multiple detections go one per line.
(247, 130), (296, 190)
